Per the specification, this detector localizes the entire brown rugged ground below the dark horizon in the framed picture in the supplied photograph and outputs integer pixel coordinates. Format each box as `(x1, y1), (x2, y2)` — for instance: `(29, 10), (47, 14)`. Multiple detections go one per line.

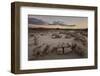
(28, 29), (88, 60)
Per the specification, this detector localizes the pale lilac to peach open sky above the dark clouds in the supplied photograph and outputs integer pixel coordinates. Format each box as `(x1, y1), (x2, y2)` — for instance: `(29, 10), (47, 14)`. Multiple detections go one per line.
(28, 15), (88, 28)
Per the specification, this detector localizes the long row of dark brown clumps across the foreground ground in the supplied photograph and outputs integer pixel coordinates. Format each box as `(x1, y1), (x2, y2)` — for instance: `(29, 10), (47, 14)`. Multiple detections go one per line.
(33, 41), (87, 58)
